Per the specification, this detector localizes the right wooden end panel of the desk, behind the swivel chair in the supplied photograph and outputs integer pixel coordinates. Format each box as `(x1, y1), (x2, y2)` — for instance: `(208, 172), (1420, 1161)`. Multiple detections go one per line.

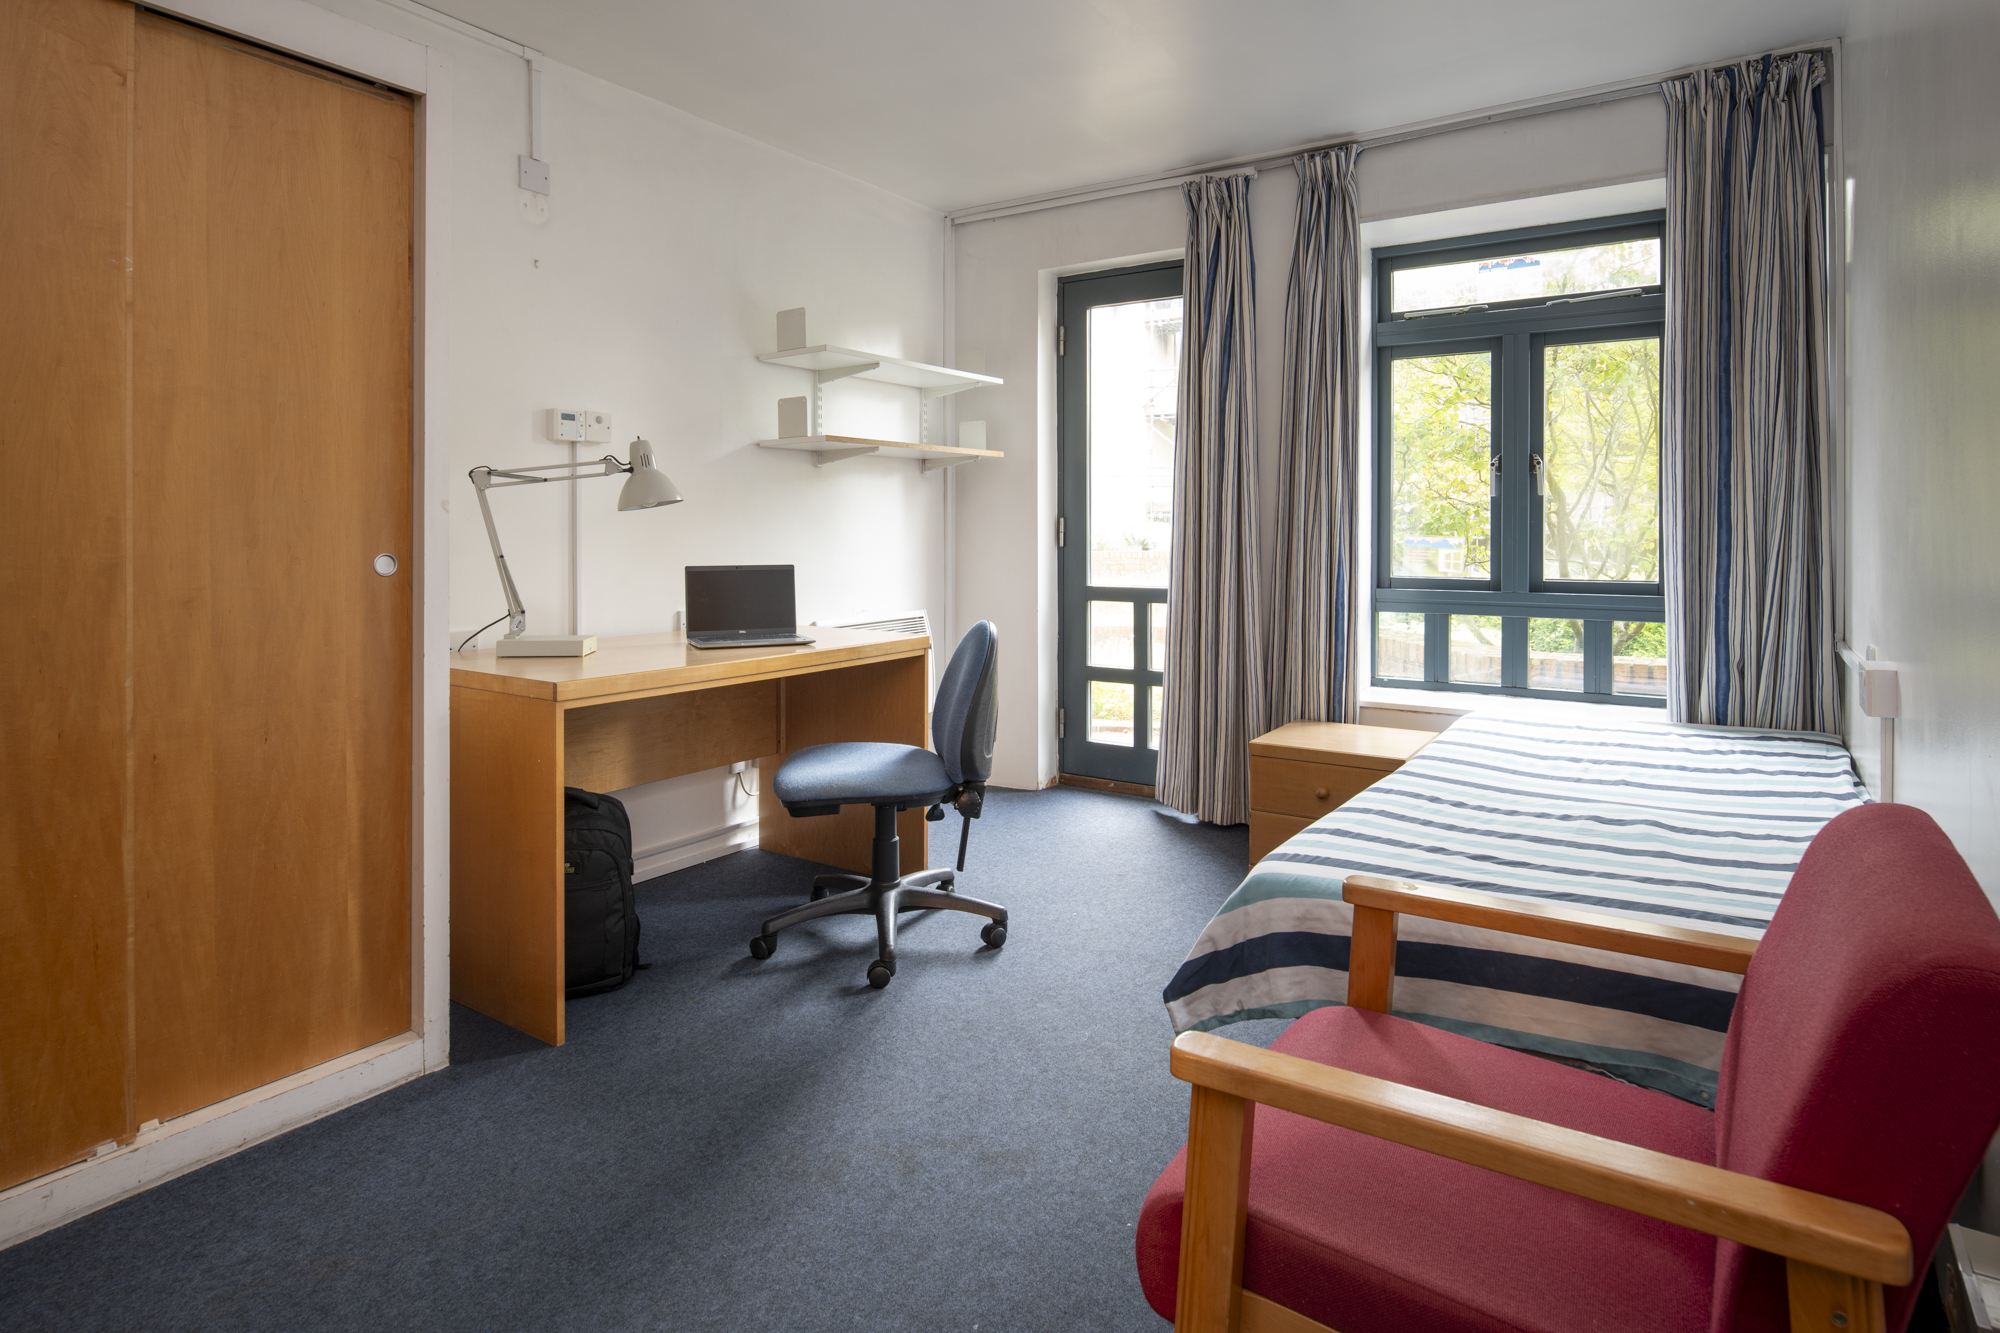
(758, 656), (930, 875)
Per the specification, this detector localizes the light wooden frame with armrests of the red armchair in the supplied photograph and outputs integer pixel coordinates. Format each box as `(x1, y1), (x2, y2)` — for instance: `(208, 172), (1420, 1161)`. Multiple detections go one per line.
(1172, 875), (1912, 1333)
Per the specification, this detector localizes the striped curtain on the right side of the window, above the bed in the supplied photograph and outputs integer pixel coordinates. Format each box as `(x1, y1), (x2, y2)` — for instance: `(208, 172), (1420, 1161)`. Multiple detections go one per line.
(1660, 54), (1840, 731)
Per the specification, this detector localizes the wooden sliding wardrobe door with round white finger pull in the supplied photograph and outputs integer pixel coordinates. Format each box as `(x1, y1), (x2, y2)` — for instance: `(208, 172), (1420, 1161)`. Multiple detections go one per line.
(132, 14), (416, 1123)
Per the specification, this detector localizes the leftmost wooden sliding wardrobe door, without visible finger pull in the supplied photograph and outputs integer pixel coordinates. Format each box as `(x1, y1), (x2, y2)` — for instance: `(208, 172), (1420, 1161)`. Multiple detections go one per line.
(0, 0), (136, 1189)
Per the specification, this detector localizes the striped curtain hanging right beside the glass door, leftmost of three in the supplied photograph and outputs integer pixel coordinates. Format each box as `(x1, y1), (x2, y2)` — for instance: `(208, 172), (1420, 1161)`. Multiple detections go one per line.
(1156, 176), (1270, 825)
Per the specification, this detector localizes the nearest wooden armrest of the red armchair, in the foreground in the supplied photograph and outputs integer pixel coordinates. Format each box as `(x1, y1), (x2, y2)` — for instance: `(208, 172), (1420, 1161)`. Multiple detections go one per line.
(1172, 1020), (1910, 1287)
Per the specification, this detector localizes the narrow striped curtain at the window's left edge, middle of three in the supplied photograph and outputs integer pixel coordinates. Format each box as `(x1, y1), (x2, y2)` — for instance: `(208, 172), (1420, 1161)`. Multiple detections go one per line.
(1270, 144), (1362, 727)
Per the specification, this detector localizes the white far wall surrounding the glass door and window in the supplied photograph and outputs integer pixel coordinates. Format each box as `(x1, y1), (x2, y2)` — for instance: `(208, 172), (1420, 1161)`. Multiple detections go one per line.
(948, 106), (1666, 787)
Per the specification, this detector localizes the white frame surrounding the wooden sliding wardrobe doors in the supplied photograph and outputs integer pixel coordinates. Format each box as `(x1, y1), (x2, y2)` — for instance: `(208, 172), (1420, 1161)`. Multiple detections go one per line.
(0, 0), (452, 1249)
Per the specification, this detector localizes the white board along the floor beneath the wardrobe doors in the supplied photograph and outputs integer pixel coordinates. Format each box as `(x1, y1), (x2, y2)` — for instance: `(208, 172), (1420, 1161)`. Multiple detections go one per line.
(0, 1033), (424, 1249)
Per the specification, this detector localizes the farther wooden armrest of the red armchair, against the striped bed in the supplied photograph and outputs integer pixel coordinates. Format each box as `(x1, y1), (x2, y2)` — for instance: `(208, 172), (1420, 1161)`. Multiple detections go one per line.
(1342, 875), (1756, 973)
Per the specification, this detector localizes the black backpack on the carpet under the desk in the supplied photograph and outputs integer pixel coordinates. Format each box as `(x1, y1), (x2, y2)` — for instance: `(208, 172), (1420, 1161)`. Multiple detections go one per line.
(562, 787), (644, 999)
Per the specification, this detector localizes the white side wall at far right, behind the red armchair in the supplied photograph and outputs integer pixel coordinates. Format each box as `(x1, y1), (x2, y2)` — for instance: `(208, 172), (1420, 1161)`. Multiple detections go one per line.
(1842, 0), (2000, 896)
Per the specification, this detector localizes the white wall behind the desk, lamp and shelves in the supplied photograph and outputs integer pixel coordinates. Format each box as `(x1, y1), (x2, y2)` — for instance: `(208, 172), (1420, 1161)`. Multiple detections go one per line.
(326, 0), (944, 860)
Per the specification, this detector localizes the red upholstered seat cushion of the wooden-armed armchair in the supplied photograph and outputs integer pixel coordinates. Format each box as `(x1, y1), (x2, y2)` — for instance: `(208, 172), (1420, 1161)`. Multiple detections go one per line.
(1138, 1007), (1716, 1333)
